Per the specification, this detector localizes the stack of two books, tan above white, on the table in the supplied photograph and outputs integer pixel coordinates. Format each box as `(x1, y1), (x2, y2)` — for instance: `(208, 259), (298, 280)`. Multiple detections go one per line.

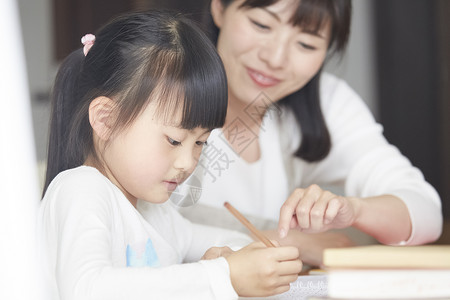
(323, 245), (450, 299)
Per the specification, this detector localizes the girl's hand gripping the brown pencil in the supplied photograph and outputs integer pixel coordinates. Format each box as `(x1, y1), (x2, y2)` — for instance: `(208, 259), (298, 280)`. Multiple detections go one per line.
(226, 242), (302, 297)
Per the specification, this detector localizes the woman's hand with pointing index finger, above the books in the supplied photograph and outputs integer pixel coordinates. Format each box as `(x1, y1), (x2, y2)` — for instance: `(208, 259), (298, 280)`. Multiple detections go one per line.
(278, 184), (359, 238)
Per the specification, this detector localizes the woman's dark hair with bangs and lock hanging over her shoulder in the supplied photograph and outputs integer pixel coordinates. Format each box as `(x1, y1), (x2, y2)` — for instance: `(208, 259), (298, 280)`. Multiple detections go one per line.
(203, 0), (352, 162)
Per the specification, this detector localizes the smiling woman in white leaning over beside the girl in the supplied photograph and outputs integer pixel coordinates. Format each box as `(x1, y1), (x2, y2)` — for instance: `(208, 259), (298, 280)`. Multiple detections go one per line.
(178, 0), (442, 263)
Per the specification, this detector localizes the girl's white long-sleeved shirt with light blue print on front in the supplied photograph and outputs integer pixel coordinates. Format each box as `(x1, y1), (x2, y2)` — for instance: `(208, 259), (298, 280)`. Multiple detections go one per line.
(38, 166), (251, 300)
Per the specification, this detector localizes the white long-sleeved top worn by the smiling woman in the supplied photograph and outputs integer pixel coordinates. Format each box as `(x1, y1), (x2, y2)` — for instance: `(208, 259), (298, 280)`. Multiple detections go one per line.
(181, 73), (442, 245)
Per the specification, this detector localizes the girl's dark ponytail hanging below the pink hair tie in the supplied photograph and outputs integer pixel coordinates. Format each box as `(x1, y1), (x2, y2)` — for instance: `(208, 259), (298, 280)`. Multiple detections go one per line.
(42, 49), (85, 195)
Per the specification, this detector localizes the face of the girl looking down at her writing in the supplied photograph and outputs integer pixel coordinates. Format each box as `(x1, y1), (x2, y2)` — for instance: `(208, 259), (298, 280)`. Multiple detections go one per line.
(103, 102), (210, 205)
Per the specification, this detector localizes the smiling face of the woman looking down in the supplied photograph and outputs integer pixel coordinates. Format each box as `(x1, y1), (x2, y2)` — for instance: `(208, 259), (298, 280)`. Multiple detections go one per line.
(211, 0), (330, 103)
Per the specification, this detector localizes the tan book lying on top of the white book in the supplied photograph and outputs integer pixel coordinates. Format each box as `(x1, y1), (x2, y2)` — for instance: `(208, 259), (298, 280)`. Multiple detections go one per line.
(323, 245), (450, 269)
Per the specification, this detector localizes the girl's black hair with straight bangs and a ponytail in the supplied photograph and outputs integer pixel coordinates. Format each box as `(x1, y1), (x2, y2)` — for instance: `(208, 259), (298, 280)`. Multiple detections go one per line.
(43, 10), (228, 194)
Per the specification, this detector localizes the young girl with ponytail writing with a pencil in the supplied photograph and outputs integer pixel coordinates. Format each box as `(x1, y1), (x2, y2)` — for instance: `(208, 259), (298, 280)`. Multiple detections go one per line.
(39, 11), (302, 300)
